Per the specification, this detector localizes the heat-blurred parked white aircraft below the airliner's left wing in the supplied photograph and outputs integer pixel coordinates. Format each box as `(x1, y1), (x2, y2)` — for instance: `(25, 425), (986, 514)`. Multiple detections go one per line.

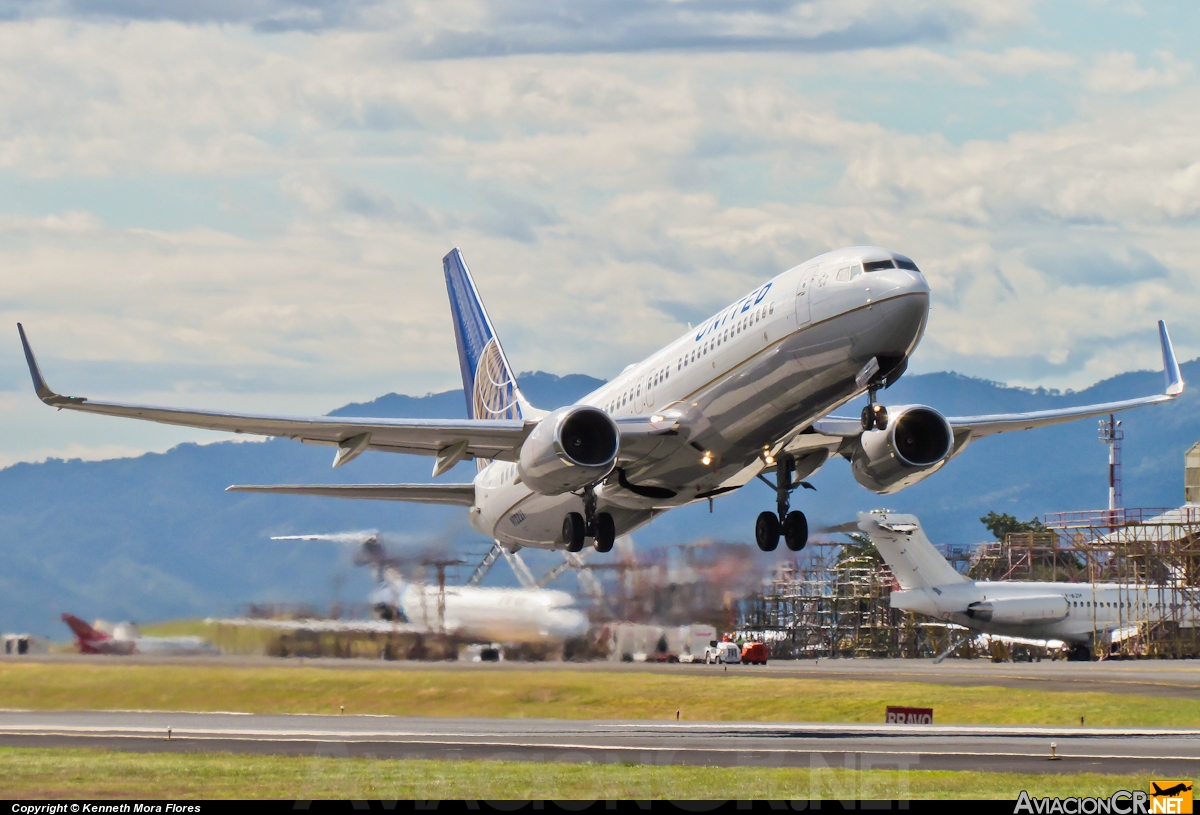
(271, 532), (588, 645)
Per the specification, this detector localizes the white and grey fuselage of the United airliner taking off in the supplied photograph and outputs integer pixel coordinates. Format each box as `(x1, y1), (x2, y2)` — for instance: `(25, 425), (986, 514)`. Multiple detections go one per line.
(470, 247), (929, 549)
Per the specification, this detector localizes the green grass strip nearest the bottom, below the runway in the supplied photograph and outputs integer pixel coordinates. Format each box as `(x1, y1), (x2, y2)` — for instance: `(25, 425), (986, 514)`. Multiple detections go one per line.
(0, 748), (1147, 801)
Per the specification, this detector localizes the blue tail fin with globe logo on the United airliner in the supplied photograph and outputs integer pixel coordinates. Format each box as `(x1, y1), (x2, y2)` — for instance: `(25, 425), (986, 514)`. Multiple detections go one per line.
(442, 248), (529, 419)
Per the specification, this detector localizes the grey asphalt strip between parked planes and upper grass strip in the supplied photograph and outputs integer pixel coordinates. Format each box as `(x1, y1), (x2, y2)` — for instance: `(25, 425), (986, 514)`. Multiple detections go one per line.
(0, 654), (1200, 700)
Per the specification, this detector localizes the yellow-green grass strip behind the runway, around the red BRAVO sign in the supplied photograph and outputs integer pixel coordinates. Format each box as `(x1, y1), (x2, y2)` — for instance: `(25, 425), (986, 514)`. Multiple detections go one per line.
(0, 663), (1200, 727)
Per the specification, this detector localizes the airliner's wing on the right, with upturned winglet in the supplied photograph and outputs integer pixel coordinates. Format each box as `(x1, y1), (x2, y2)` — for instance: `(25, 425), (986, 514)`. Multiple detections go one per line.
(806, 320), (1183, 454)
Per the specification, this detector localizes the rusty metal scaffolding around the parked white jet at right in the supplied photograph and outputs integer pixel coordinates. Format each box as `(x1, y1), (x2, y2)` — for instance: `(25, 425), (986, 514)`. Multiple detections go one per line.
(738, 507), (1200, 660)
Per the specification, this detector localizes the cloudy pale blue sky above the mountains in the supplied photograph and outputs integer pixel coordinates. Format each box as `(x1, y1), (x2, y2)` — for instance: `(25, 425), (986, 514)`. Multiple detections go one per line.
(0, 0), (1200, 465)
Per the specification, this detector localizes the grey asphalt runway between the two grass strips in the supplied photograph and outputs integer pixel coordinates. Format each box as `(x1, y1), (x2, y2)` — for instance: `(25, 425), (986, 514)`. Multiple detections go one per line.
(0, 711), (1200, 778)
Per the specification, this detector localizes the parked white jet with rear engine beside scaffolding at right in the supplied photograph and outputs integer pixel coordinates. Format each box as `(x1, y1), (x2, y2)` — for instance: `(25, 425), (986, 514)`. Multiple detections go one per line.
(858, 510), (1200, 657)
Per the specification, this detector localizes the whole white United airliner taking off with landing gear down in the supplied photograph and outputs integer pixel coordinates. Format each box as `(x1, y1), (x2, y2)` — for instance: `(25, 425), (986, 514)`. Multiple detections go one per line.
(18, 246), (1183, 552)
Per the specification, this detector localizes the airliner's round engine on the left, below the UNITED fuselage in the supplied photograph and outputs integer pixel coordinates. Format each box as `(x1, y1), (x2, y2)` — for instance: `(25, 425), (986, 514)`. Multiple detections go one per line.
(517, 406), (620, 496)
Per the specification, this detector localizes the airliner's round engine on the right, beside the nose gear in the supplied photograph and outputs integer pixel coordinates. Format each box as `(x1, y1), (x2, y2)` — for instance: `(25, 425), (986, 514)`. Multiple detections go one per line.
(851, 404), (954, 495)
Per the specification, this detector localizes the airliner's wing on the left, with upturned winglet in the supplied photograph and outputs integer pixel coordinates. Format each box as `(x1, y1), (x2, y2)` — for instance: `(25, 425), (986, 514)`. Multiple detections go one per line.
(17, 323), (535, 475)
